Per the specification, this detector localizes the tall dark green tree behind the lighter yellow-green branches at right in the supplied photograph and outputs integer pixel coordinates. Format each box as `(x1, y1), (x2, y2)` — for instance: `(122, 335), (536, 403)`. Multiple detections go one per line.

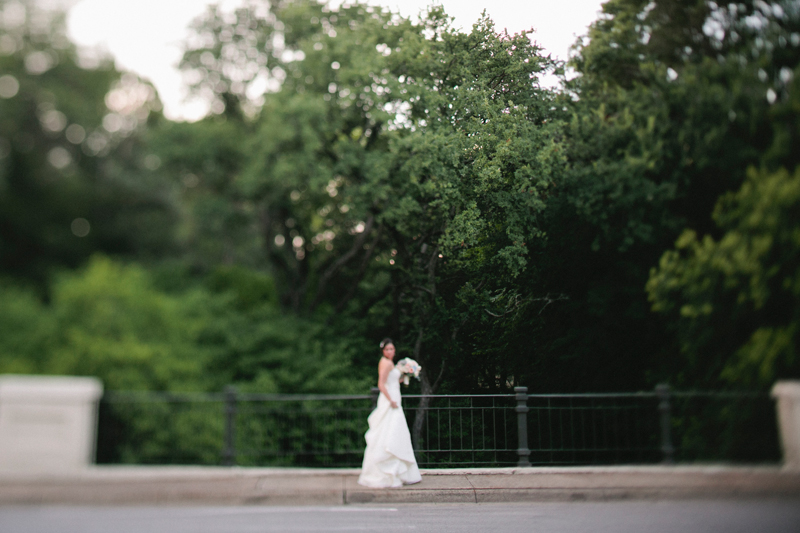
(527, 0), (798, 390)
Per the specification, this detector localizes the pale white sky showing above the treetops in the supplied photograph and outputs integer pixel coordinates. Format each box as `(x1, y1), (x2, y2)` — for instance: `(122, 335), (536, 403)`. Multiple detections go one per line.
(62, 0), (603, 120)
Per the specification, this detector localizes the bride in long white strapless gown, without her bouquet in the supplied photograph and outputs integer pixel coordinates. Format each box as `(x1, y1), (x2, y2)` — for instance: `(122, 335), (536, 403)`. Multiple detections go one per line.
(358, 339), (422, 488)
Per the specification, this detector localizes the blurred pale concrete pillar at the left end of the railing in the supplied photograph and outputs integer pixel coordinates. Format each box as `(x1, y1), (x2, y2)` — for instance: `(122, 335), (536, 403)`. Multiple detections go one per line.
(0, 375), (103, 474)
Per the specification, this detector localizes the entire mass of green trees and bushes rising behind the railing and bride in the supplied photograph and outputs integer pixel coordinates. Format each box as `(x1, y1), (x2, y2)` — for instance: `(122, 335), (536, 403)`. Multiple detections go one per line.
(0, 0), (800, 457)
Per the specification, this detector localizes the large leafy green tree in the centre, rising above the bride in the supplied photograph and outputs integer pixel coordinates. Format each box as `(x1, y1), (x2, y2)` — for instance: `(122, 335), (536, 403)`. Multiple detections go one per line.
(177, 2), (560, 391)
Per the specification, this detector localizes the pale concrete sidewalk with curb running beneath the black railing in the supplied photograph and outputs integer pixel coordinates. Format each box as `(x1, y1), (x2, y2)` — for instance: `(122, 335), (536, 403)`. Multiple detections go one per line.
(0, 465), (800, 505)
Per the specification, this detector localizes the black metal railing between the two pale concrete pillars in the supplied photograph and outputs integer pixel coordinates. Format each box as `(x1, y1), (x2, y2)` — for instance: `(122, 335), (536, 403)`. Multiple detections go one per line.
(98, 385), (780, 467)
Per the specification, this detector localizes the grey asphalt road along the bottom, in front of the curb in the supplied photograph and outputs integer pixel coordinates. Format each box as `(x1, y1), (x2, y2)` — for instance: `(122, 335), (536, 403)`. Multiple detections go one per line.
(0, 500), (800, 533)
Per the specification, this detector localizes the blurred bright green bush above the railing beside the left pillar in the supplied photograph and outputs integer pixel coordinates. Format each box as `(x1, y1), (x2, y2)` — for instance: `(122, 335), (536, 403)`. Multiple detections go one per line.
(43, 256), (210, 391)
